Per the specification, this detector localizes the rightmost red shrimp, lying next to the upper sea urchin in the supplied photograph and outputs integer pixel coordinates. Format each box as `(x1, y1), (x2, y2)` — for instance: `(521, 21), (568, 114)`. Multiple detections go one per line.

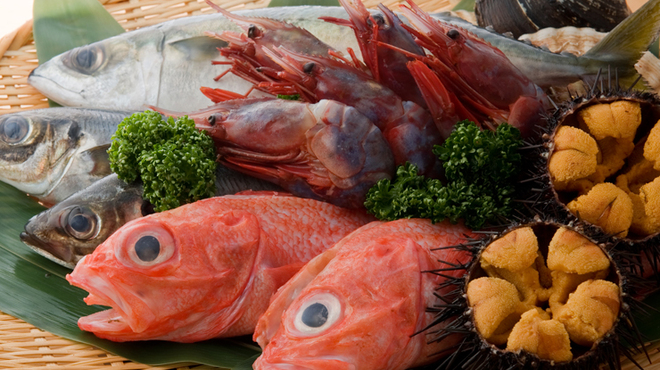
(394, 0), (549, 137)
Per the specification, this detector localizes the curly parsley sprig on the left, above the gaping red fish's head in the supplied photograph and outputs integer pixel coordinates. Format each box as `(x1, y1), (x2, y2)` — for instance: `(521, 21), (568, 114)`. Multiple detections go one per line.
(108, 111), (216, 212)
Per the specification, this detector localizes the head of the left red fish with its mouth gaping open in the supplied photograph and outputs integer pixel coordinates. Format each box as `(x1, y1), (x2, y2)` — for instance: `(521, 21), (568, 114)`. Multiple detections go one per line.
(67, 205), (261, 342)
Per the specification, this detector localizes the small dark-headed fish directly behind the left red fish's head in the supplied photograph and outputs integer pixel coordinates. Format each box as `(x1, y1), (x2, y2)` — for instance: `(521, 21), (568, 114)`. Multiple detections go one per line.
(21, 164), (281, 269)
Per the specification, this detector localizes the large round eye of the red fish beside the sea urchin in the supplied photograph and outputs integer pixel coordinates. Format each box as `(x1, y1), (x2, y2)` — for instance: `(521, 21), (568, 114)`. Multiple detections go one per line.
(293, 293), (342, 336)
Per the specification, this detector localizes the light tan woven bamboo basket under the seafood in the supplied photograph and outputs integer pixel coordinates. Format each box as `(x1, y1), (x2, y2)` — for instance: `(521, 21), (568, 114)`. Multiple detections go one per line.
(0, 0), (660, 370)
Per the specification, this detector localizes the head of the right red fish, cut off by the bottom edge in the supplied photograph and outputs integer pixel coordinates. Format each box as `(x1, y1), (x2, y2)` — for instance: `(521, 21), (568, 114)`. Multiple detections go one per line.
(254, 237), (433, 370)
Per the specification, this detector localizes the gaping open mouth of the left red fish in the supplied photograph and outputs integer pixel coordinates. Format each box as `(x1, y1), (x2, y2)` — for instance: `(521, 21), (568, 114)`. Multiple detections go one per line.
(66, 257), (155, 341)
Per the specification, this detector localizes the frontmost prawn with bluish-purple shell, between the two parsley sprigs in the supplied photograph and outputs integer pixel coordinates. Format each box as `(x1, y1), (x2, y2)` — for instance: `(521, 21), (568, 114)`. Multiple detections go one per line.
(157, 98), (395, 208)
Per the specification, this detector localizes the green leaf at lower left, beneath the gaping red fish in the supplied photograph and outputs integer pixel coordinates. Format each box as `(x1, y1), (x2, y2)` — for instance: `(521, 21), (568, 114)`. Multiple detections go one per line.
(0, 179), (259, 370)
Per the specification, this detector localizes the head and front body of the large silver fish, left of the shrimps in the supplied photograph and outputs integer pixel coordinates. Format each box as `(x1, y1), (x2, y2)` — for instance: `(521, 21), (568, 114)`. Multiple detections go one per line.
(28, 6), (359, 111)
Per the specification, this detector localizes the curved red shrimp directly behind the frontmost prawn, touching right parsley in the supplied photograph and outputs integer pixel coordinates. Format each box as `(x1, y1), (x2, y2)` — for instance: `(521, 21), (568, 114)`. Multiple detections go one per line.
(202, 48), (442, 177)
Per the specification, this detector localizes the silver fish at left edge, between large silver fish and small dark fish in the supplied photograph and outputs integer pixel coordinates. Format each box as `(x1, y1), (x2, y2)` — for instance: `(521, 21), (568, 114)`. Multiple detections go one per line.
(0, 108), (132, 206)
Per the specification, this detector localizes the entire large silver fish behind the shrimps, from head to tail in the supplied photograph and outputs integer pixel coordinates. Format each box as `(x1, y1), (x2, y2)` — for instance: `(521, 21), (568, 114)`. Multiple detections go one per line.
(28, 0), (660, 111)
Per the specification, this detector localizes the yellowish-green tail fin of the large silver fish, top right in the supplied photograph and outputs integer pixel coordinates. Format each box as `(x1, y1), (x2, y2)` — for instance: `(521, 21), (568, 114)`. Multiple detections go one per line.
(584, 0), (660, 62)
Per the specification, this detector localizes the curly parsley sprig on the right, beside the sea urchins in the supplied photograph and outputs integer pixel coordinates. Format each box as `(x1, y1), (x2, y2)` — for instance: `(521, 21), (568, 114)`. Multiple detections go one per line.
(365, 121), (522, 230)
